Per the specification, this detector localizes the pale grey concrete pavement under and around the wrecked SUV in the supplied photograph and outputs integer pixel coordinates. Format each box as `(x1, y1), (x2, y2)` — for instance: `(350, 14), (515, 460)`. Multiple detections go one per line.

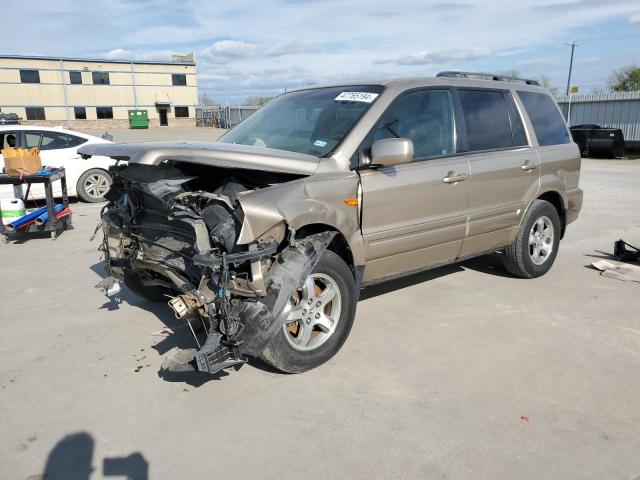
(0, 149), (640, 480)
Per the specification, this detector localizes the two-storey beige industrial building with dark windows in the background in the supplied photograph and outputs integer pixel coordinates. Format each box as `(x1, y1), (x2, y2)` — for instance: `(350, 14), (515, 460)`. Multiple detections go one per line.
(0, 55), (198, 128)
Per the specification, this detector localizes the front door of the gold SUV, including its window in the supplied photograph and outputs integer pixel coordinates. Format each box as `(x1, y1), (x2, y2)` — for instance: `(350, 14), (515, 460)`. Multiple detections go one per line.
(360, 89), (469, 282)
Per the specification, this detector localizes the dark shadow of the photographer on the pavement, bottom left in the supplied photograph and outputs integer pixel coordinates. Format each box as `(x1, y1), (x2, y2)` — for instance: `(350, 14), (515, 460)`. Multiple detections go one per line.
(39, 432), (149, 480)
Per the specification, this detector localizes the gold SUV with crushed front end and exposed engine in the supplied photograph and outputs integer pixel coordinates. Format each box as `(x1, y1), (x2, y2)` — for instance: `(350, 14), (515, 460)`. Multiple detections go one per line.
(80, 72), (582, 373)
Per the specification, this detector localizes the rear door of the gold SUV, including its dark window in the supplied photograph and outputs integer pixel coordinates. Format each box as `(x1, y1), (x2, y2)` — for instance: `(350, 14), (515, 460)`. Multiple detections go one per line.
(456, 88), (540, 256)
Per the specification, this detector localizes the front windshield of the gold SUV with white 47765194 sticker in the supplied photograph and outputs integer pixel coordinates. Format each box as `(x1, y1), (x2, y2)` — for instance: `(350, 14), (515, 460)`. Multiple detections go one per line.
(219, 85), (383, 157)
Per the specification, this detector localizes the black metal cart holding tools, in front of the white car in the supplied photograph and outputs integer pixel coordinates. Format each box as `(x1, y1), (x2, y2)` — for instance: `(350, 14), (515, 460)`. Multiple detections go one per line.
(0, 168), (73, 242)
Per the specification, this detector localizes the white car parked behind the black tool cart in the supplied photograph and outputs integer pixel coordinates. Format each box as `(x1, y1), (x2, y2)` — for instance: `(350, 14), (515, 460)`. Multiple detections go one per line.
(0, 125), (116, 202)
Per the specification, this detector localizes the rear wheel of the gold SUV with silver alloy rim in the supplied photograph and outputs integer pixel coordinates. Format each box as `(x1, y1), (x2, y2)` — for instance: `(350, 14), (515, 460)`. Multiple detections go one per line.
(504, 200), (562, 278)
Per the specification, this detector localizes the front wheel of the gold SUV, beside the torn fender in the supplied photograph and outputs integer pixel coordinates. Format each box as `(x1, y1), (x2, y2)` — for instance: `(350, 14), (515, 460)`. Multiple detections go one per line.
(260, 250), (358, 373)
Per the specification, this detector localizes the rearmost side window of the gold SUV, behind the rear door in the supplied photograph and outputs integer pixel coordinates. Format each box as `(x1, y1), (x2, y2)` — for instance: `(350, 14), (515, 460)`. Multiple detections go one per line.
(518, 92), (570, 146)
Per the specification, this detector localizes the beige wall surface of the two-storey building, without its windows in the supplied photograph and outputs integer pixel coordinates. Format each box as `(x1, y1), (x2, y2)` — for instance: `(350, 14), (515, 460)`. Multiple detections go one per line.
(0, 58), (198, 127)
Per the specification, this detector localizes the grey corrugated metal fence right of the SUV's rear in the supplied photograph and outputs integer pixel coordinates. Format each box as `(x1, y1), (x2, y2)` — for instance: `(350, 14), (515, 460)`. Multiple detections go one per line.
(557, 92), (640, 142)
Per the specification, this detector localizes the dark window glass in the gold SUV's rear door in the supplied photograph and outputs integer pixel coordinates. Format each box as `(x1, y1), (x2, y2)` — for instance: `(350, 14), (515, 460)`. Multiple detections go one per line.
(458, 90), (513, 151)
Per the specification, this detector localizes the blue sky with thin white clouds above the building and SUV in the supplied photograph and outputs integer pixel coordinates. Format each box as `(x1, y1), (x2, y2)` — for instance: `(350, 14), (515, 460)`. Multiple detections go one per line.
(0, 0), (640, 104)
